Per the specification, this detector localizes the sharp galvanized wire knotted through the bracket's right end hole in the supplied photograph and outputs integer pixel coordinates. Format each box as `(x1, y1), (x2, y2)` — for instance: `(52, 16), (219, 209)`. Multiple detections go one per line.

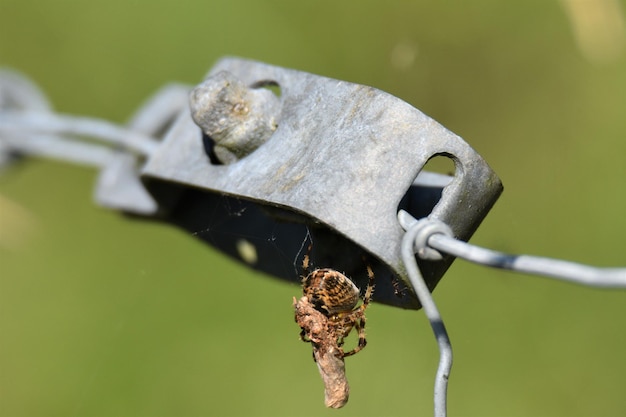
(398, 210), (626, 417)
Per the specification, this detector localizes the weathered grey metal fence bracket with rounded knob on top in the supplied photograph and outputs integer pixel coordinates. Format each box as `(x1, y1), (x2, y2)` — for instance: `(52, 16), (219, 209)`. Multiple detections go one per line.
(141, 58), (502, 308)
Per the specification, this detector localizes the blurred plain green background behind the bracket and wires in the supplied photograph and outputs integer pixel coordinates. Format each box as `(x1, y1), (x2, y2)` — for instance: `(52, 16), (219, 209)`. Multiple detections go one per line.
(0, 0), (626, 417)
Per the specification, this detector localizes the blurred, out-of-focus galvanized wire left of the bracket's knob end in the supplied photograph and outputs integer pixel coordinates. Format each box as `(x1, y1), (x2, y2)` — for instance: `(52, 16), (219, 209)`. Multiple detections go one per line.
(0, 69), (189, 168)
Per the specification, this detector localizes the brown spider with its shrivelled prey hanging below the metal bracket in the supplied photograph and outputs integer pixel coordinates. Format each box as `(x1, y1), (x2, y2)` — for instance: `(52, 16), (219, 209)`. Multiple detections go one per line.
(293, 247), (374, 408)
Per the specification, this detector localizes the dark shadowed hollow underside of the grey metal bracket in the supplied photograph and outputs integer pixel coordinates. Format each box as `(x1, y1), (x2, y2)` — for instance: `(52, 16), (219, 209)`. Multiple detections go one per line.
(162, 184), (416, 308)
